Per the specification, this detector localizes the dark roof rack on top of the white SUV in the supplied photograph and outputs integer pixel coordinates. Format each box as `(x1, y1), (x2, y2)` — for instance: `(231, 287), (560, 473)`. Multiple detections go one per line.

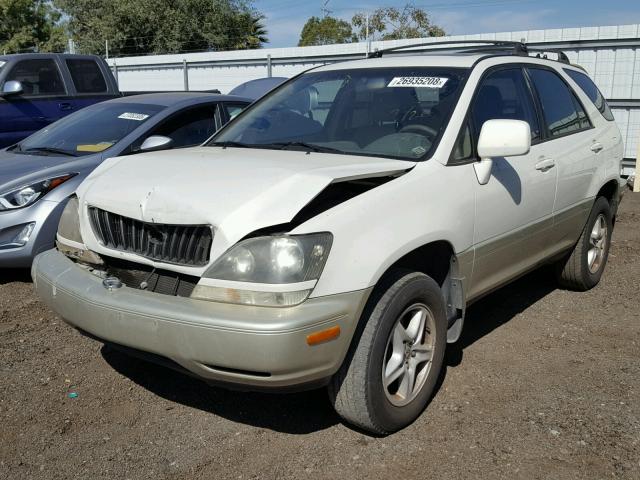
(368, 40), (571, 64)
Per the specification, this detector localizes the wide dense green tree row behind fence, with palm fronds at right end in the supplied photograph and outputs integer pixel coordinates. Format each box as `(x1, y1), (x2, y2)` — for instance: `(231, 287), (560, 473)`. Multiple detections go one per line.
(54, 0), (266, 55)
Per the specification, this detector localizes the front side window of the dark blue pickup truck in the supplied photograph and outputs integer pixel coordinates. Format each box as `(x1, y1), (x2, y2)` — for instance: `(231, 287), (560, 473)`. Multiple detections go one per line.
(5, 59), (66, 95)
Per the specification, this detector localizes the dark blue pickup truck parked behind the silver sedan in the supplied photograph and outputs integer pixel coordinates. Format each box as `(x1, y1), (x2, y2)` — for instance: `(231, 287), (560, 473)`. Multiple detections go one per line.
(0, 53), (120, 148)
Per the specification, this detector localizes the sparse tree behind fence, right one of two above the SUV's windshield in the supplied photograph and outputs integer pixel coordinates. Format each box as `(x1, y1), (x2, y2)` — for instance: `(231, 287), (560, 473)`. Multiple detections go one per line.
(351, 3), (445, 40)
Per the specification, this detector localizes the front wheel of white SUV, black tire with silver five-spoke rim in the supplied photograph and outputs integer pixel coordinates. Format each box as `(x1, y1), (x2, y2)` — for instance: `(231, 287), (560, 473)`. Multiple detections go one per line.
(328, 270), (447, 434)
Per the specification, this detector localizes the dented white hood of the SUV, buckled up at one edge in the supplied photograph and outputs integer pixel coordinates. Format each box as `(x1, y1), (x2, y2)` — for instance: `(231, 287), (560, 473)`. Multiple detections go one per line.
(78, 147), (414, 248)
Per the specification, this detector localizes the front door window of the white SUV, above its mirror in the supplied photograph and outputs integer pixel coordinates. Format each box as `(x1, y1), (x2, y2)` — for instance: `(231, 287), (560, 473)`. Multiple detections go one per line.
(470, 68), (541, 142)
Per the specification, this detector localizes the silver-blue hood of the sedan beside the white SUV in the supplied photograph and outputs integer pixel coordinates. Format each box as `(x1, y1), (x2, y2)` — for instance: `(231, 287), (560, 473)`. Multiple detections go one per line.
(0, 150), (100, 192)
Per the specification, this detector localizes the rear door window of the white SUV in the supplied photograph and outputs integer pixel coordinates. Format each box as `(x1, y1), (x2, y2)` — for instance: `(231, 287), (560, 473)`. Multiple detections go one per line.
(528, 68), (591, 138)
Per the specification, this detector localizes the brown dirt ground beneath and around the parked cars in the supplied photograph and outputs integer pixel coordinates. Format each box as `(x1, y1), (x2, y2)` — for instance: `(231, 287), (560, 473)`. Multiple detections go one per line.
(0, 189), (640, 480)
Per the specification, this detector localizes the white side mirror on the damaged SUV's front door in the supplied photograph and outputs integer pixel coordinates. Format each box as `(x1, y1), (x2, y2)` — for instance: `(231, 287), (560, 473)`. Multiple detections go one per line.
(473, 120), (531, 185)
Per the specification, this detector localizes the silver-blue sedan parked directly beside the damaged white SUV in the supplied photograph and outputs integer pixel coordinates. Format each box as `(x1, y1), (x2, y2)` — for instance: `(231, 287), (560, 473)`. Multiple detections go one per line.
(0, 92), (250, 268)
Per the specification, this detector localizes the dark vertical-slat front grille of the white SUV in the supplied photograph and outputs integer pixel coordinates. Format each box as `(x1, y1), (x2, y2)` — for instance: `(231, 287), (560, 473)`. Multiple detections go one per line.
(89, 207), (213, 266)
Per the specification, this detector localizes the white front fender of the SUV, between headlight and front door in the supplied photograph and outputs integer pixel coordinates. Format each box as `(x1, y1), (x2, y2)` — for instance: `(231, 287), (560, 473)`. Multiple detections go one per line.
(293, 161), (477, 297)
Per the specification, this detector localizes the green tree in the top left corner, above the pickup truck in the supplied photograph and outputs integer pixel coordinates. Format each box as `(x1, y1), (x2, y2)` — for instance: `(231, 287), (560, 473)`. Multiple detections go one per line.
(0, 0), (66, 53)
